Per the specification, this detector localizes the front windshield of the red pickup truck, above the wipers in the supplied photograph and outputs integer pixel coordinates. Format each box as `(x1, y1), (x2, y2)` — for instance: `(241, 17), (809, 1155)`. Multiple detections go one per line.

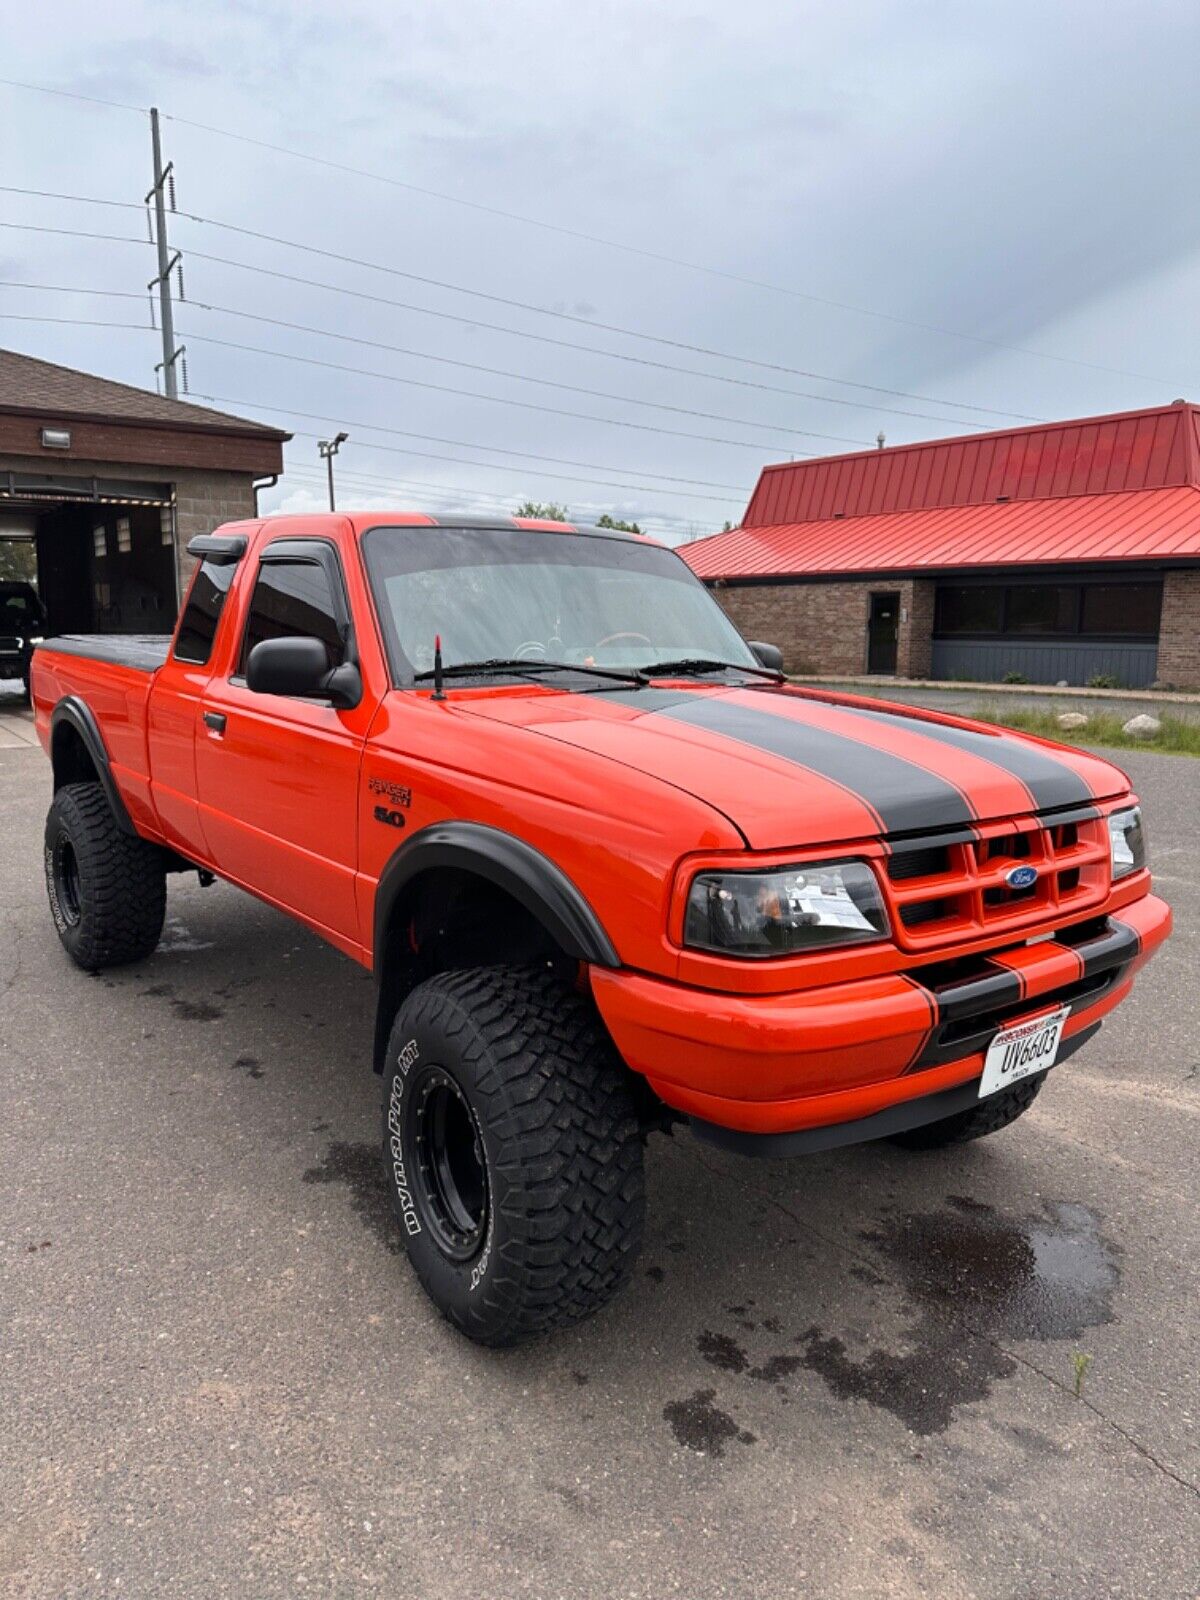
(363, 528), (758, 682)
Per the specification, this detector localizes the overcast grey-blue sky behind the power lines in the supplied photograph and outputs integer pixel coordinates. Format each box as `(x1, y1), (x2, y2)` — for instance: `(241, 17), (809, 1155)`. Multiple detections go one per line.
(0, 0), (1200, 539)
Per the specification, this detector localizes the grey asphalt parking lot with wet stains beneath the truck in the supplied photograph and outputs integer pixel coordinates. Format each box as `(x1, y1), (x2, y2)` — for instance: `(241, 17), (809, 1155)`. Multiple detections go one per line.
(0, 704), (1200, 1600)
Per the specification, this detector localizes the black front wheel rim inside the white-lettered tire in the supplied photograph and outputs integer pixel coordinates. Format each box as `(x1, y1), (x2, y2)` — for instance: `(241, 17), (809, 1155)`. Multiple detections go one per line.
(406, 1066), (490, 1261)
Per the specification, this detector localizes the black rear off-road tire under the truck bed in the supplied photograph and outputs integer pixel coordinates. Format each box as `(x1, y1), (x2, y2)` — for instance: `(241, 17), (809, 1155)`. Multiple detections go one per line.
(45, 784), (166, 973)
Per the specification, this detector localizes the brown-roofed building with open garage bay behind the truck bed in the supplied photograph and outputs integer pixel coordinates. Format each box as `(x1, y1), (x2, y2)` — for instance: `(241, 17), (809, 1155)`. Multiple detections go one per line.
(0, 350), (291, 634)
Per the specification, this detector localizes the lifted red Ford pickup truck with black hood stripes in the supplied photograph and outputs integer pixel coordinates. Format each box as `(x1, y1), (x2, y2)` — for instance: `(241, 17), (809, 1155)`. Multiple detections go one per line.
(32, 512), (1171, 1344)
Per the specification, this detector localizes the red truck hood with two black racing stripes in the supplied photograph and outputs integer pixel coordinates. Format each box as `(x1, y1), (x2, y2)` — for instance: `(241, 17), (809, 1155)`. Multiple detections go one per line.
(458, 683), (1130, 850)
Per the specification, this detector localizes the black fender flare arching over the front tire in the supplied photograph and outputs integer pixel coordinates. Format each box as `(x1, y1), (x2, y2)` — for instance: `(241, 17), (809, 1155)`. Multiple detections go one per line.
(371, 822), (621, 982)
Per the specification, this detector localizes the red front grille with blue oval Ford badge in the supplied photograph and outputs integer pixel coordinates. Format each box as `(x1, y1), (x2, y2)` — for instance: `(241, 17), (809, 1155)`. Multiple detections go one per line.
(888, 808), (1109, 950)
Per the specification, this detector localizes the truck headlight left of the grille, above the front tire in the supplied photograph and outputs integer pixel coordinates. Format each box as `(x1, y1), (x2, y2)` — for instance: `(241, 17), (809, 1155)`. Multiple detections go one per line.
(683, 861), (888, 955)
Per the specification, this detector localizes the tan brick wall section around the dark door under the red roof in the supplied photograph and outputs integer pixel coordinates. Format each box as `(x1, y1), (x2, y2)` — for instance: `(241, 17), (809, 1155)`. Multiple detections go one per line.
(714, 579), (934, 677)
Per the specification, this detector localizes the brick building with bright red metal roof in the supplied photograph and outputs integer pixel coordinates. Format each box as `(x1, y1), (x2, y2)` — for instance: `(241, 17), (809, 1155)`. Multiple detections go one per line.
(680, 400), (1200, 688)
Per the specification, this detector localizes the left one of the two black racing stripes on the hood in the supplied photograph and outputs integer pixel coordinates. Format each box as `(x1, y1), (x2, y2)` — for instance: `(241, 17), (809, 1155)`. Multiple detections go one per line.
(629, 690), (976, 834)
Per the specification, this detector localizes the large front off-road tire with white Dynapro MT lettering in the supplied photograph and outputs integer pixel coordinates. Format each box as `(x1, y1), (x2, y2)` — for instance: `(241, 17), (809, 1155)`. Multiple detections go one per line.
(382, 966), (645, 1346)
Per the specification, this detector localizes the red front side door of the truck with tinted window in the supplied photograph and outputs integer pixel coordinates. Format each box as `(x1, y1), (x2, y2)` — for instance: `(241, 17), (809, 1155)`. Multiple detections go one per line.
(195, 536), (376, 949)
